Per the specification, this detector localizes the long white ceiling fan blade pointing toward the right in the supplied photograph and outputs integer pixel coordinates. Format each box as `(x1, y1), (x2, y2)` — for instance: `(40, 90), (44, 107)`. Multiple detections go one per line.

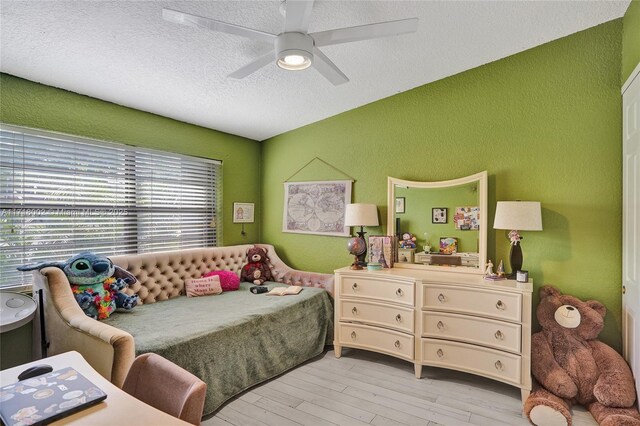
(309, 18), (418, 47)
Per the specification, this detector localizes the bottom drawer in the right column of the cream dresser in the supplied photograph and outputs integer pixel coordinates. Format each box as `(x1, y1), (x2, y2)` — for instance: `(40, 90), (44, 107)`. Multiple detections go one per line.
(421, 339), (522, 385)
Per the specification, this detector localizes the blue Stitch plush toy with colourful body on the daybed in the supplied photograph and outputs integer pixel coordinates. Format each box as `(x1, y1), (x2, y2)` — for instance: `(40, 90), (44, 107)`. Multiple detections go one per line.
(18, 252), (138, 320)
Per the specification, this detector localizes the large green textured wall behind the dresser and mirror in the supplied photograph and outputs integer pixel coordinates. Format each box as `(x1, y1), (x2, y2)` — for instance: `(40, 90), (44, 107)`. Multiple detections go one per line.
(262, 19), (622, 350)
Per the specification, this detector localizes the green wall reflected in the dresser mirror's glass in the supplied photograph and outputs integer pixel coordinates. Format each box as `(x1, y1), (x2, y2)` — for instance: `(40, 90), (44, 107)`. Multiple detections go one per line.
(395, 183), (480, 252)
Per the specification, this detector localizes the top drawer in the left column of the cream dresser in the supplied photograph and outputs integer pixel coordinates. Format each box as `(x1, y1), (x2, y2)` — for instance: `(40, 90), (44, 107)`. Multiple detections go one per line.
(340, 277), (414, 306)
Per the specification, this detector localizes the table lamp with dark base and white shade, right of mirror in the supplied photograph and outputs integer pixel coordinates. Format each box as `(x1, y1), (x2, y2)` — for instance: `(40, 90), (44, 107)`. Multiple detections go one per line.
(493, 201), (542, 279)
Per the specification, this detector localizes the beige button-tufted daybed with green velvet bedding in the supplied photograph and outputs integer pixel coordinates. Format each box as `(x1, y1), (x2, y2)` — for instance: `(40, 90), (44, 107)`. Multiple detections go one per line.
(34, 244), (333, 415)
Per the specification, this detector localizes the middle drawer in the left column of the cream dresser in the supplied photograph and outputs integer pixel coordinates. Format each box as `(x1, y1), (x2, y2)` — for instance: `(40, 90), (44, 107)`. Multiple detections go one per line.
(340, 299), (414, 333)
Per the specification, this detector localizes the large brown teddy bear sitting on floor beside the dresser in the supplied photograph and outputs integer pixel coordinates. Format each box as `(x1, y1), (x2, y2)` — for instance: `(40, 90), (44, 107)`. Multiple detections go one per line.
(524, 286), (640, 426)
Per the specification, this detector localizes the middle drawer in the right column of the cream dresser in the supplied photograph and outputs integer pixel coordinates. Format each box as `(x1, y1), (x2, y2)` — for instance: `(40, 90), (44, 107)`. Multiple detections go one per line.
(422, 311), (522, 352)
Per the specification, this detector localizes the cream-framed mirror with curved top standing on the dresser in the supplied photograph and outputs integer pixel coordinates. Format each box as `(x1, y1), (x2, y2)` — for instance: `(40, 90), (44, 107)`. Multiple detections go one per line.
(387, 171), (488, 274)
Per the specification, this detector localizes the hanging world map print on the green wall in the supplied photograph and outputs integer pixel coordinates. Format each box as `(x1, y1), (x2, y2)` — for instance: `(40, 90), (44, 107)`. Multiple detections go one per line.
(282, 180), (352, 237)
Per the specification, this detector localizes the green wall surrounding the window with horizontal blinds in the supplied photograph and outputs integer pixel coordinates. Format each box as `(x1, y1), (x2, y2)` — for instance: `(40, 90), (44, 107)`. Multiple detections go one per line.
(0, 74), (261, 245)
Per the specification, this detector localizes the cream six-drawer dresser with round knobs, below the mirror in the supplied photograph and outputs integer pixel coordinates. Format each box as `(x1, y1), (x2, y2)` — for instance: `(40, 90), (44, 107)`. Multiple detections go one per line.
(334, 268), (533, 402)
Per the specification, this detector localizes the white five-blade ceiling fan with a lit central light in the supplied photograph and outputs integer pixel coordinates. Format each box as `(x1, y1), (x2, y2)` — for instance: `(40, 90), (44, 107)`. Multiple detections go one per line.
(162, 0), (418, 86)
